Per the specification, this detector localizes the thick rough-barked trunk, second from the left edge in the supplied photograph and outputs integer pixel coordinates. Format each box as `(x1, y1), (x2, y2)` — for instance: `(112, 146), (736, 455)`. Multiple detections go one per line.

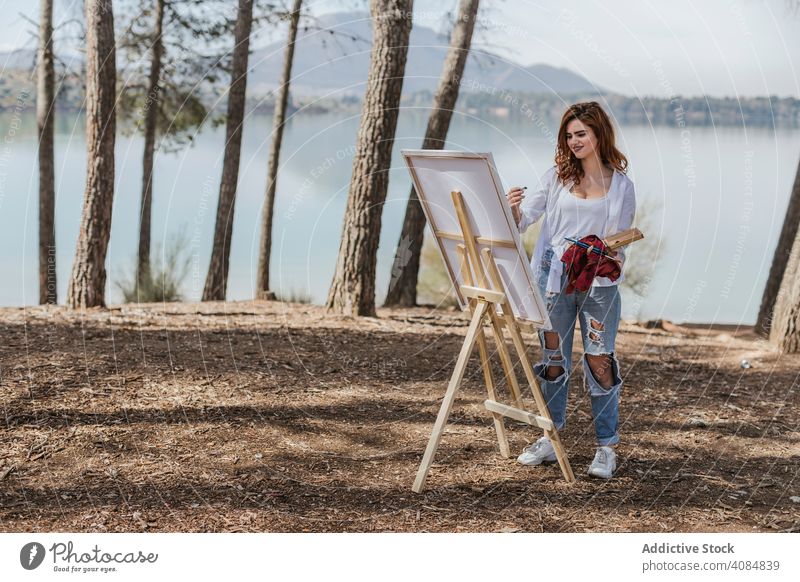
(67, 0), (117, 308)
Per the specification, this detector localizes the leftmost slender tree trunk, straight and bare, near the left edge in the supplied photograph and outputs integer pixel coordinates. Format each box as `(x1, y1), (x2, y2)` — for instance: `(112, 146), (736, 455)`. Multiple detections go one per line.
(36, 0), (58, 305)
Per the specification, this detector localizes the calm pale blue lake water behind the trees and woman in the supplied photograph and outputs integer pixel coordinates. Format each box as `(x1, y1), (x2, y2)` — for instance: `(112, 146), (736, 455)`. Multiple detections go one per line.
(0, 111), (800, 324)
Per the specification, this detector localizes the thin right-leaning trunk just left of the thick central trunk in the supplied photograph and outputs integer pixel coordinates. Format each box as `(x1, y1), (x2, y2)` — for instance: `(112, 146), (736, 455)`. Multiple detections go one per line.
(256, 0), (303, 299)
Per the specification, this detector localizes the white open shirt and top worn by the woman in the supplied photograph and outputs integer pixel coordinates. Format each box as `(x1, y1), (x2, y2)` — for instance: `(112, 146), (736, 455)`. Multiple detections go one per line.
(519, 166), (636, 293)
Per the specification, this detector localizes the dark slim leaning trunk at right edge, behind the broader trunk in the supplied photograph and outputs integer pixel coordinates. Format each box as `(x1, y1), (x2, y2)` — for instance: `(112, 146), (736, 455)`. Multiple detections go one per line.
(755, 157), (800, 336)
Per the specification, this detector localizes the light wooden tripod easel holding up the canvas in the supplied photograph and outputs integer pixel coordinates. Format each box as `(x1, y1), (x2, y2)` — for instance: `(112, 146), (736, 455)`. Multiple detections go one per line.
(412, 191), (575, 493)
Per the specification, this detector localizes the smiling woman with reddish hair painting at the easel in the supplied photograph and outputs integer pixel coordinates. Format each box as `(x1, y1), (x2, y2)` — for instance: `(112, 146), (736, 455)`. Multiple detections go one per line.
(507, 101), (636, 479)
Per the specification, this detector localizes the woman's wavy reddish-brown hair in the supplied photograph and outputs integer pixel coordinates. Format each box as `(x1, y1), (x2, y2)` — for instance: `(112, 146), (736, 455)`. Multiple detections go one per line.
(555, 101), (628, 185)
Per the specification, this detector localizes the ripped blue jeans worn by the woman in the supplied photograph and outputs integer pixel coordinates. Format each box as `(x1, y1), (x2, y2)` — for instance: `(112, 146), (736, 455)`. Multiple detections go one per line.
(534, 248), (622, 446)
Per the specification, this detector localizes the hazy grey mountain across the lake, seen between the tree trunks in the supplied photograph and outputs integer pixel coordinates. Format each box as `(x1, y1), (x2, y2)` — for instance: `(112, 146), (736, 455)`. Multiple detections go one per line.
(247, 12), (604, 96)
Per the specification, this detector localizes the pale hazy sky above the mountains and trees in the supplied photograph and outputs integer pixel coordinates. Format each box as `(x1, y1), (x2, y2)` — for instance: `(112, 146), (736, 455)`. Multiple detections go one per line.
(0, 0), (800, 98)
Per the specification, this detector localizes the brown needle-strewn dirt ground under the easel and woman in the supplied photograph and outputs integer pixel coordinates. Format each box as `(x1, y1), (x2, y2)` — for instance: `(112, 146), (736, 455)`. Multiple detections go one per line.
(0, 301), (800, 532)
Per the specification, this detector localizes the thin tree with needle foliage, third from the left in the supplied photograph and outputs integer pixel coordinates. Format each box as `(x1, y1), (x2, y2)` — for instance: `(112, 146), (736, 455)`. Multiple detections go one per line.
(117, 0), (232, 300)
